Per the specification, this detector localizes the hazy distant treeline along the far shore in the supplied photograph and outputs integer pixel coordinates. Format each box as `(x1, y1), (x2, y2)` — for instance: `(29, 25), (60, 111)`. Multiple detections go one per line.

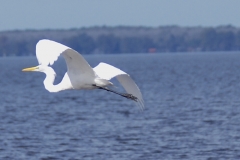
(0, 26), (240, 56)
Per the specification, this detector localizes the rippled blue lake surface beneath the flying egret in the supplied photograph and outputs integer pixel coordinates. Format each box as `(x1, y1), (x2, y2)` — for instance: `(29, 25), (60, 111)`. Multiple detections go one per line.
(0, 52), (240, 160)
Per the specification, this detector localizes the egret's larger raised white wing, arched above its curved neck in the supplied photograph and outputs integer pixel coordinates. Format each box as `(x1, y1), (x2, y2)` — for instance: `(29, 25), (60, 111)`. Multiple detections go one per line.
(36, 39), (95, 88)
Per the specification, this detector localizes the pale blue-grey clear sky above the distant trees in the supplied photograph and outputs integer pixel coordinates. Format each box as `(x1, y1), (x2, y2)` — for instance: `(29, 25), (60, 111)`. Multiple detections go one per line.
(0, 0), (240, 31)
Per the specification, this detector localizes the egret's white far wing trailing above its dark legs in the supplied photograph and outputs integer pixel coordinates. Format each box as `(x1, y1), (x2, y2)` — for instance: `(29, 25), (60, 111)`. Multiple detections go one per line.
(93, 62), (144, 108)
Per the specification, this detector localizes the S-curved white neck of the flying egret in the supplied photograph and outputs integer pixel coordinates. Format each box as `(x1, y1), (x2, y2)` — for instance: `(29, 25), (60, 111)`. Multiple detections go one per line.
(43, 67), (62, 92)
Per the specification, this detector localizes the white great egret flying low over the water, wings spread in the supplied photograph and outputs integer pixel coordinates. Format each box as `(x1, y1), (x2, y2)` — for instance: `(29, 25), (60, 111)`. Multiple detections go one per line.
(22, 39), (144, 109)
